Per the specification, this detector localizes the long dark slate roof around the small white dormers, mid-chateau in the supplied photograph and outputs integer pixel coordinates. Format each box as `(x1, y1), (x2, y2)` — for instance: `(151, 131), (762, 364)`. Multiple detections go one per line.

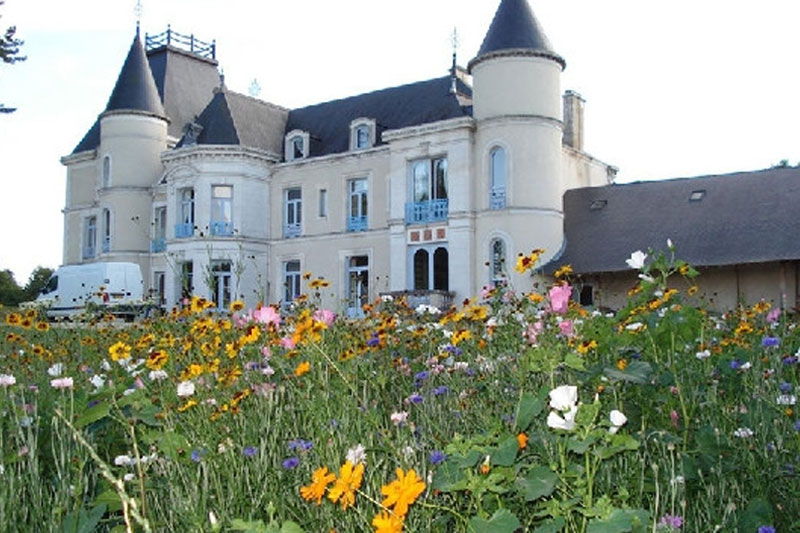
(285, 76), (472, 157)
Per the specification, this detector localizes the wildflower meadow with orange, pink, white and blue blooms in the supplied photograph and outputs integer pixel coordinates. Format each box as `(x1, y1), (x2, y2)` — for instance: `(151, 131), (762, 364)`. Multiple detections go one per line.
(0, 248), (800, 533)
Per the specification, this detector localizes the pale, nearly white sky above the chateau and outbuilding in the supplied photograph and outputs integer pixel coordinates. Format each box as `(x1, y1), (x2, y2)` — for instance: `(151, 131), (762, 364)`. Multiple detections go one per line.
(0, 0), (800, 284)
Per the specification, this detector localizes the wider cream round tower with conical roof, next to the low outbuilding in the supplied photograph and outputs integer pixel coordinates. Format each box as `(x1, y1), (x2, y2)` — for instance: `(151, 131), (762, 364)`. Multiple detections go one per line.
(468, 0), (566, 289)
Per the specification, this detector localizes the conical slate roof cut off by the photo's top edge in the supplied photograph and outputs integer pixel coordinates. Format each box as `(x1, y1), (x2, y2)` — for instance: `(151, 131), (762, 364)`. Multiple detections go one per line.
(469, 0), (566, 70)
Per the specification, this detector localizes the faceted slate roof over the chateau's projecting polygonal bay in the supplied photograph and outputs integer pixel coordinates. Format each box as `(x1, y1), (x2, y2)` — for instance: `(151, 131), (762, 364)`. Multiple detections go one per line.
(178, 89), (289, 154)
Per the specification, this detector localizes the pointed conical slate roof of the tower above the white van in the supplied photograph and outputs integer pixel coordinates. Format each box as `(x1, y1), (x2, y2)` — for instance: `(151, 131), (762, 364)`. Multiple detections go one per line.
(106, 31), (166, 118)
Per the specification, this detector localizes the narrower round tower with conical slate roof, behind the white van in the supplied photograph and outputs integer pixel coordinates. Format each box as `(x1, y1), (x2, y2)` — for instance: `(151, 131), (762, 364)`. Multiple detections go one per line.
(96, 30), (168, 266)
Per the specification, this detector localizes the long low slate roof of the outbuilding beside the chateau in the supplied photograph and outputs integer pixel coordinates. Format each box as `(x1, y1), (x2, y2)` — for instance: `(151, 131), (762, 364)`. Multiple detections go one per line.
(546, 167), (800, 274)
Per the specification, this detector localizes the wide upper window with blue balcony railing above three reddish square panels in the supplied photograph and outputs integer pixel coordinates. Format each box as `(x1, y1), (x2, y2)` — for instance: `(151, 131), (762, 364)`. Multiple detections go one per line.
(406, 158), (448, 224)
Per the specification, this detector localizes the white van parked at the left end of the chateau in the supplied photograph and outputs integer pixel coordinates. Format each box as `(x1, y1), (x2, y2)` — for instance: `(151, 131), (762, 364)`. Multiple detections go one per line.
(36, 263), (144, 318)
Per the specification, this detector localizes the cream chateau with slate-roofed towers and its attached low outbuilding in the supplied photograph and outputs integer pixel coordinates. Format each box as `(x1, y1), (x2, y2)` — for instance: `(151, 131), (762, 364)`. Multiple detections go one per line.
(62, 0), (800, 314)
